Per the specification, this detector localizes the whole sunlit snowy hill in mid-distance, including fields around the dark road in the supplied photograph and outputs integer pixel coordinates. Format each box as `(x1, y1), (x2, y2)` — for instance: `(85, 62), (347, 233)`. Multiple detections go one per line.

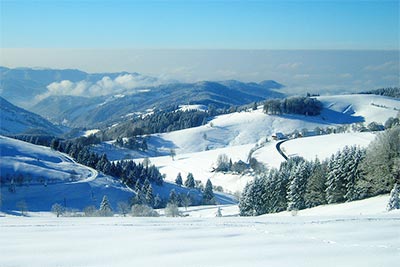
(91, 95), (400, 192)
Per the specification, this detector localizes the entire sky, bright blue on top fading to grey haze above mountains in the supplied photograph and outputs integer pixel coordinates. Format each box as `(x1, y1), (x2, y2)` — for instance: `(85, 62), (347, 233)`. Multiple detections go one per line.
(0, 0), (400, 93)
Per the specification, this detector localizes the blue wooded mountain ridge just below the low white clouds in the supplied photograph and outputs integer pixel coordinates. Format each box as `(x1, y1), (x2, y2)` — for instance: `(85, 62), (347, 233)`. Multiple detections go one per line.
(32, 81), (283, 127)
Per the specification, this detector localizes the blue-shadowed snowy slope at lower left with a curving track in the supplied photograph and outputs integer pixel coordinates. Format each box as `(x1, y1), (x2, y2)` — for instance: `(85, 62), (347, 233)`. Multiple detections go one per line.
(0, 136), (132, 211)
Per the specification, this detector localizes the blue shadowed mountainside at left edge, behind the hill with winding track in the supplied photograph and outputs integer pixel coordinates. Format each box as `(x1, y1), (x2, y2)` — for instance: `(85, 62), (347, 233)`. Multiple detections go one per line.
(0, 97), (62, 135)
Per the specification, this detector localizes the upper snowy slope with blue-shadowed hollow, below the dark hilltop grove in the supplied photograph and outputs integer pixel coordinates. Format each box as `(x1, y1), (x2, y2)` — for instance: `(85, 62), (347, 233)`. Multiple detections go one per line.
(150, 95), (400, 153)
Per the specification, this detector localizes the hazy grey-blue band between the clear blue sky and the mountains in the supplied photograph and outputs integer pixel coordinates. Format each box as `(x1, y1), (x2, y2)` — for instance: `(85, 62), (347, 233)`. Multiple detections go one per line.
(0, 48), (400, 93)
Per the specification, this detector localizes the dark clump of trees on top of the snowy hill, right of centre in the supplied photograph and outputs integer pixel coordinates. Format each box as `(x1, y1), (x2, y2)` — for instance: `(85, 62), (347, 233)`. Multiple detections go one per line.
(264, 97), (322, 116)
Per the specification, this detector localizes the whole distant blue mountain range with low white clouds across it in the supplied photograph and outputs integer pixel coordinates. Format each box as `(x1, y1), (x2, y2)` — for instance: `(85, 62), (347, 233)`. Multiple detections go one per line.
(0, 67), (284, 127)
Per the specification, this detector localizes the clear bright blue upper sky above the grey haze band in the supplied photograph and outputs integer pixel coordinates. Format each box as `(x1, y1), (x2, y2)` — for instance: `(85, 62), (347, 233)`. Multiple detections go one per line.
(0, 0), (400, 50)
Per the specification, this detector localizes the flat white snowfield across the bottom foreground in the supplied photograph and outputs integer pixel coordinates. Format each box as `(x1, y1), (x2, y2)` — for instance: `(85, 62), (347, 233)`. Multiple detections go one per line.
(0, 196), (400, 267)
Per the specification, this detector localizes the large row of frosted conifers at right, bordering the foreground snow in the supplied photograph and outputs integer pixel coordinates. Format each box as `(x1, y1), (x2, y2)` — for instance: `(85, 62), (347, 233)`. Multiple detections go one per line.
(239, 127), (400, 216)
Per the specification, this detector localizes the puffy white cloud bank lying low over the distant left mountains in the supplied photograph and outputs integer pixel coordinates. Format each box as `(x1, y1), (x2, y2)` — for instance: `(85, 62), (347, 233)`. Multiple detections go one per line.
(36, 74), (167, 101)
